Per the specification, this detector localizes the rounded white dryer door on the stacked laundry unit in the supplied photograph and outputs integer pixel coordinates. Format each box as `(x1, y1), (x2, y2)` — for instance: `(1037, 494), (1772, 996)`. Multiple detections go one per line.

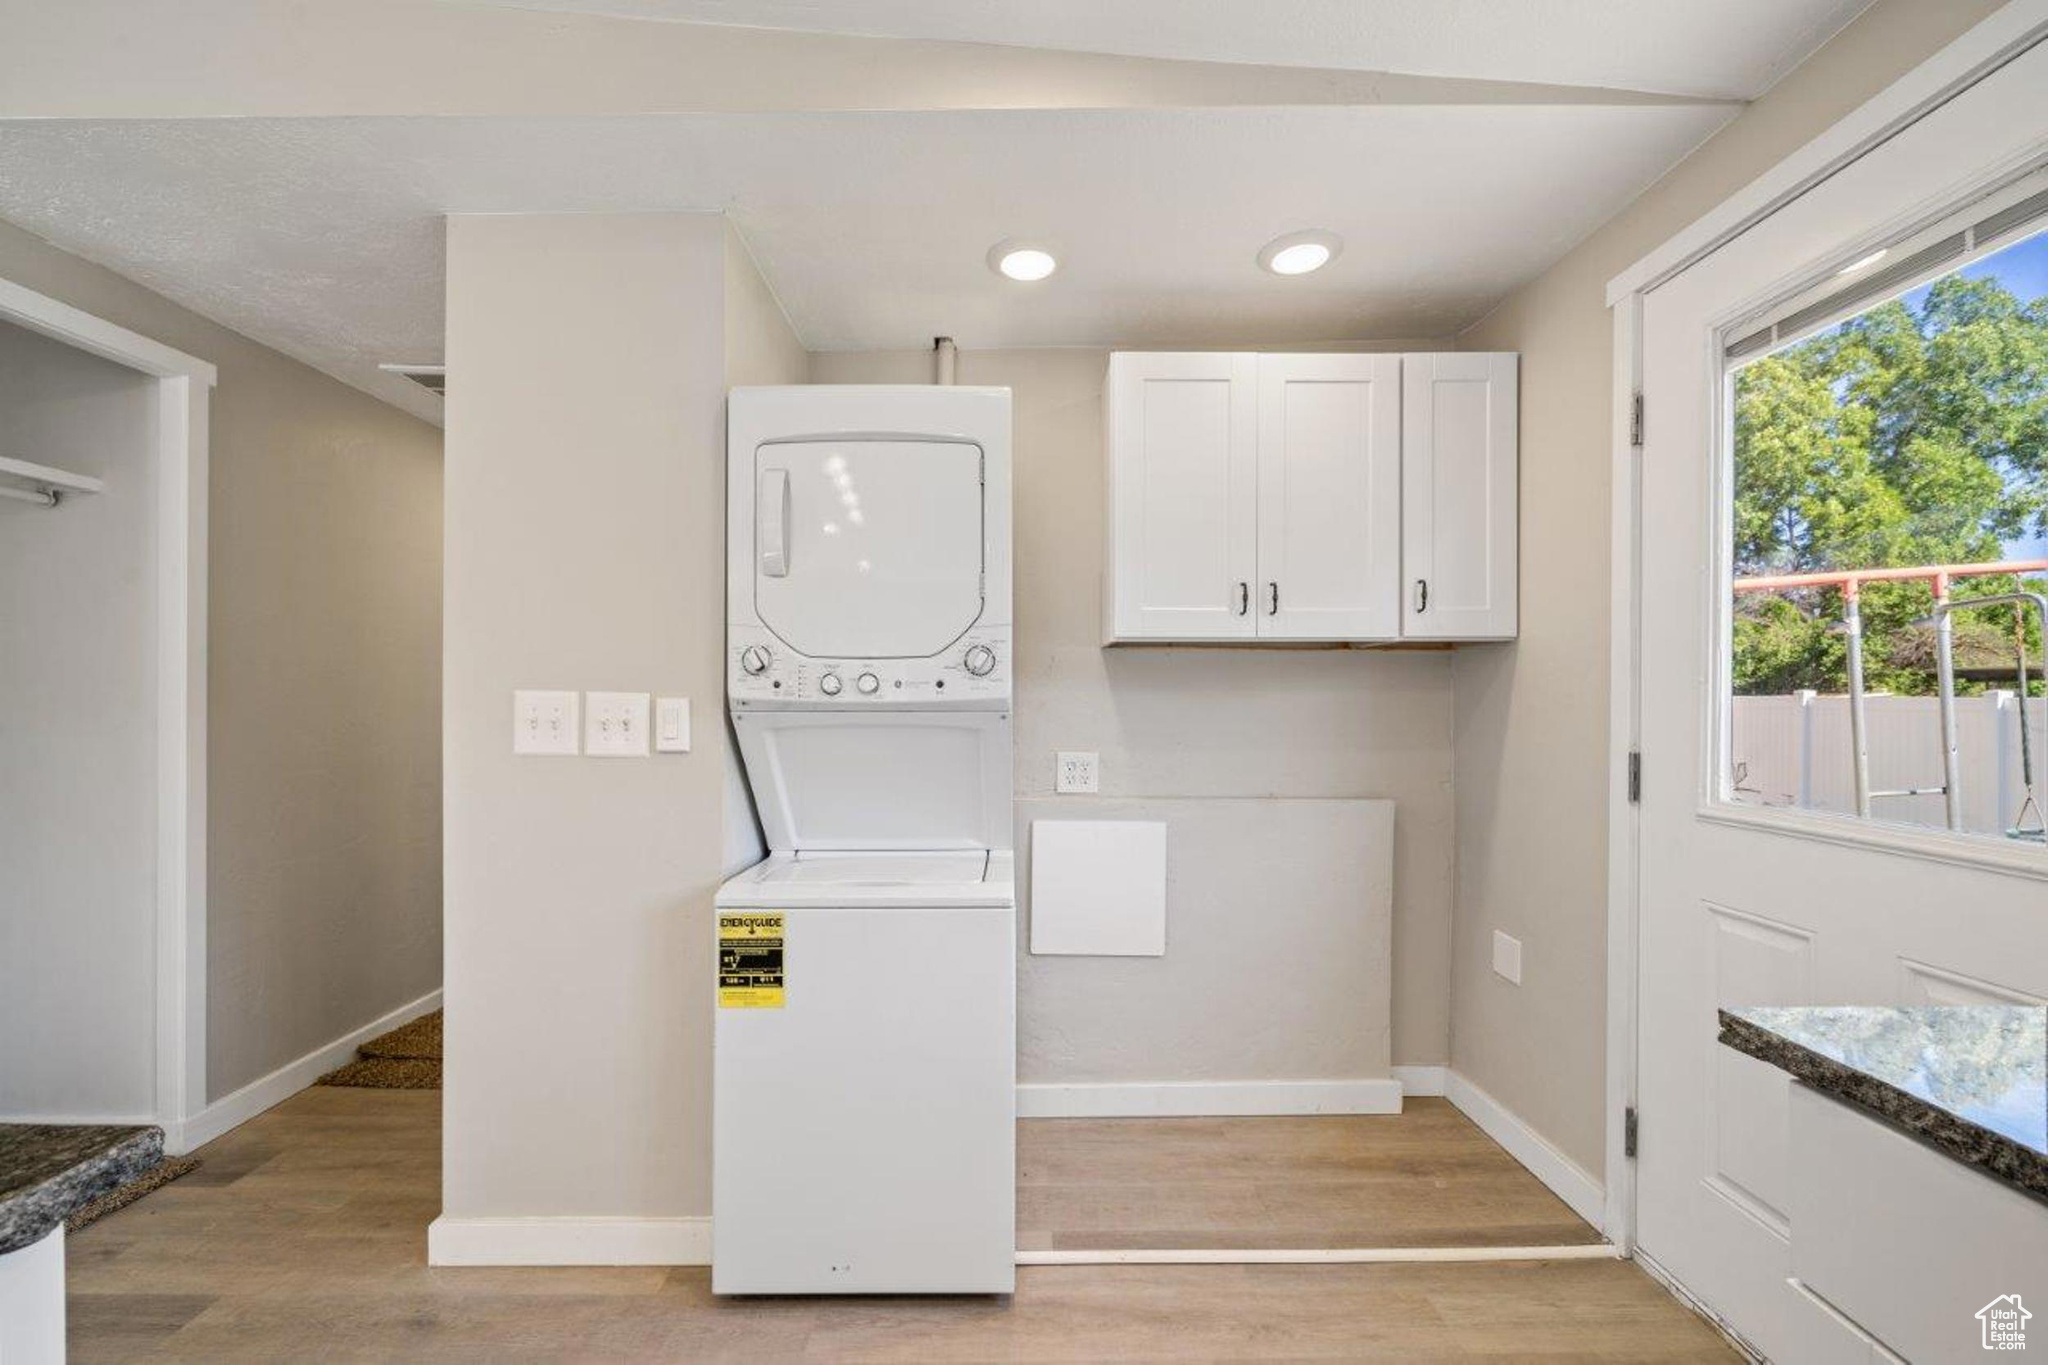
(754, 440), (983, 659)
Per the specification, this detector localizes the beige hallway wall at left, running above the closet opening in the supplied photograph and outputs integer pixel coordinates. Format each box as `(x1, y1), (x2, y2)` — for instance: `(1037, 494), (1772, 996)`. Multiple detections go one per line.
(0, 223), (440, 1099)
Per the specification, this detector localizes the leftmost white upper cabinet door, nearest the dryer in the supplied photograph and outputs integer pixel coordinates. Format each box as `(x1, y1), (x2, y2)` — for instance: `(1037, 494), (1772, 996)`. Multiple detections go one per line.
(1104, 352), (1257, 641)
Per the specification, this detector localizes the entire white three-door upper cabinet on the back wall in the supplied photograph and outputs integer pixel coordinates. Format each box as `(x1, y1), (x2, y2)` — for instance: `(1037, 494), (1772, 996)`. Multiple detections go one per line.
(1104, 352), (1516, 643)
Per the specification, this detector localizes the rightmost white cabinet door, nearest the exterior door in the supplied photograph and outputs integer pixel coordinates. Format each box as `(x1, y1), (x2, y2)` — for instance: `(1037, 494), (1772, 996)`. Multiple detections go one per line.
(1401, 352), (1515, 641)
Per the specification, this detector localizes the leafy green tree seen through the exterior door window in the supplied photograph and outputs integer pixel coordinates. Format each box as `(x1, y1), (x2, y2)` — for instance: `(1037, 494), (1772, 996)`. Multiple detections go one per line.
(1735, 276), (2048, 694)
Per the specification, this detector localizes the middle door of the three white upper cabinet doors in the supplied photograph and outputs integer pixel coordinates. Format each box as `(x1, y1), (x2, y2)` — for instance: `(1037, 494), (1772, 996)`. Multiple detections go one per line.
(1253, 356), (1401, 641)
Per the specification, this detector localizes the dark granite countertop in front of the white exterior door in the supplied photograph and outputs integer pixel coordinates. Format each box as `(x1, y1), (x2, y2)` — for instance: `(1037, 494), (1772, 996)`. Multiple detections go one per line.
(1720, 1005), (2048, 1199)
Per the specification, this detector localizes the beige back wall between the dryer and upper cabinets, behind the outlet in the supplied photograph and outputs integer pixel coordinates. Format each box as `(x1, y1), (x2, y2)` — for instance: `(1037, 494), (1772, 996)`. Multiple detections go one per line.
(811, 348), (1452, 1081)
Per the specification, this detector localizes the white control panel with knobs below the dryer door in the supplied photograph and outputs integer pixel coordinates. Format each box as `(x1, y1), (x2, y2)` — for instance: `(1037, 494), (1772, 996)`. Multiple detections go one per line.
(725, 626), (1010, 710)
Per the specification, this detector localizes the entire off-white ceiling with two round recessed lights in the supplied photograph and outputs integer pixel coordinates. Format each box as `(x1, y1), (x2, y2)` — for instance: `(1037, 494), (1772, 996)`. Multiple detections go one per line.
(0, 0), (1862, 417)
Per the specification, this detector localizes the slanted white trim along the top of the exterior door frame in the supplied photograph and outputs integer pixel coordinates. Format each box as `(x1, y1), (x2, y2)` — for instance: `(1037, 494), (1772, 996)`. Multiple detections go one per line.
(1608, 0), (2048, 307)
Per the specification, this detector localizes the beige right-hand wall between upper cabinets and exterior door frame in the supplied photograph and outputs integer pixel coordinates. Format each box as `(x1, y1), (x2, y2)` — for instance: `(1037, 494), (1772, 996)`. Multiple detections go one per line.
(1452, 0), (1999, 1175)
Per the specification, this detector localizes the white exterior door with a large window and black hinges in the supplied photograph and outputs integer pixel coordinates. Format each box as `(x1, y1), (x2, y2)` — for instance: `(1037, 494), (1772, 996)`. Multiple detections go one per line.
(1630, 47), (2048, 1363)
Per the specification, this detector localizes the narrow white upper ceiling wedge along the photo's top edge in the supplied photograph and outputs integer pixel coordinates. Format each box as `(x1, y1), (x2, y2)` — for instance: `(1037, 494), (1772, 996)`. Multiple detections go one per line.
(464, 0), (1870, 100)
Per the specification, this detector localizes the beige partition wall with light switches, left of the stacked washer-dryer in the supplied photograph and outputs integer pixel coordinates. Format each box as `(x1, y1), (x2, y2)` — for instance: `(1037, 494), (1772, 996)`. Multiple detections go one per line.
(442, 215), (803, 1220)
